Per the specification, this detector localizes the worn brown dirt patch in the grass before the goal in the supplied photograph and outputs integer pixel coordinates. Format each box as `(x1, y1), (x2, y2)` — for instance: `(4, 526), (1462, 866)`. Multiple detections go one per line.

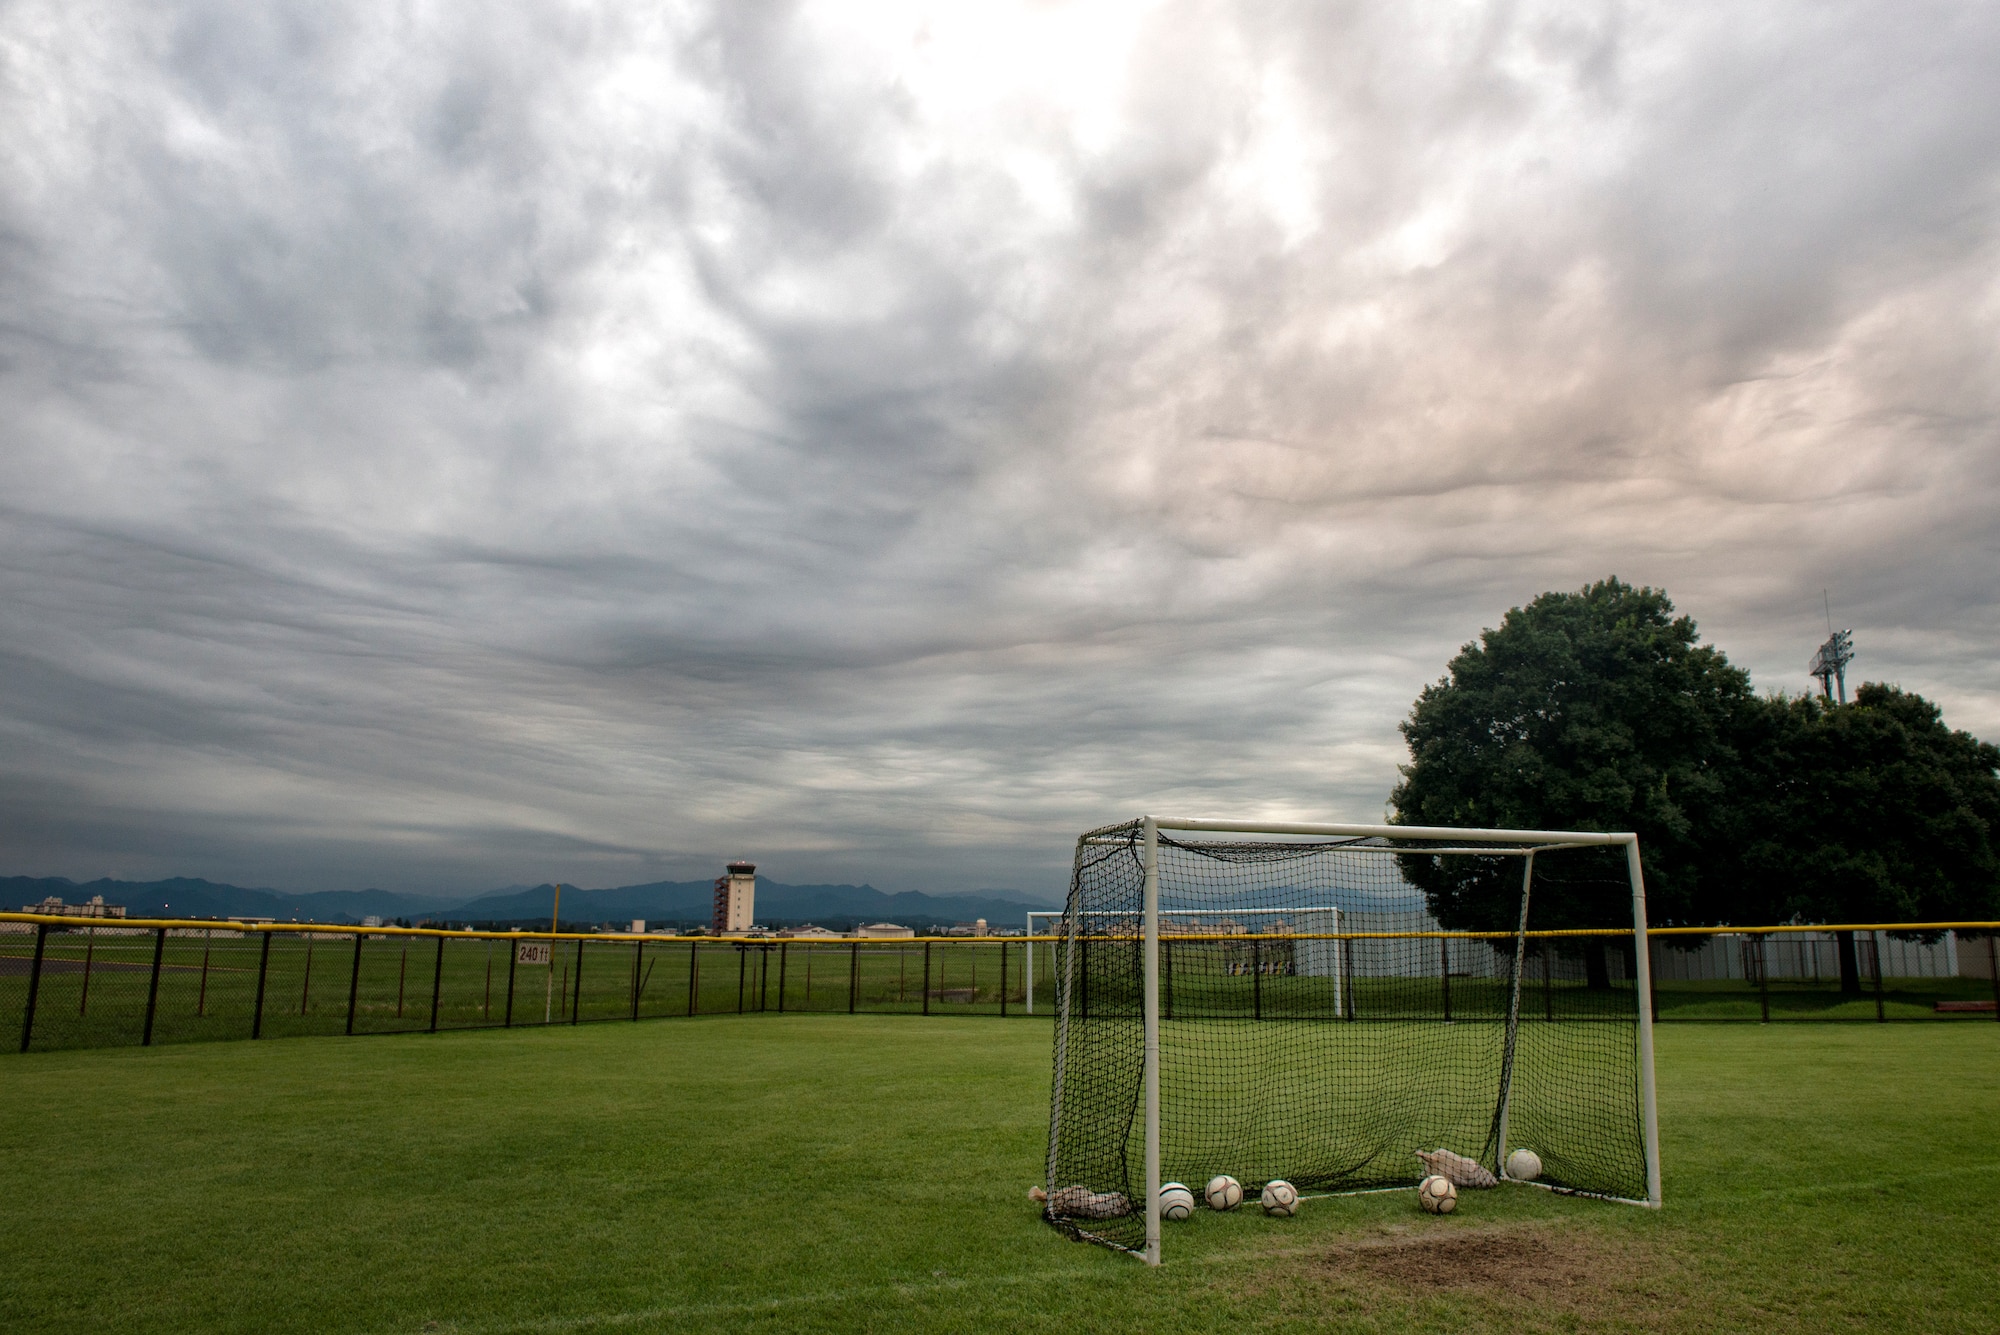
(1318, 1227), (1652, 1307)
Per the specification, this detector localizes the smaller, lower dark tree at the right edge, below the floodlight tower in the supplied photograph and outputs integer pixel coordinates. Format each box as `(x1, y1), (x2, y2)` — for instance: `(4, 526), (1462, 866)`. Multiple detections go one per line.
(1722, 681), (2000, 991)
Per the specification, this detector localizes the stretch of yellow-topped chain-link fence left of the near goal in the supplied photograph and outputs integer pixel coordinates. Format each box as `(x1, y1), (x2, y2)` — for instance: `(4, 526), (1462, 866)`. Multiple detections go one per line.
(0, 913), (1028, 1051)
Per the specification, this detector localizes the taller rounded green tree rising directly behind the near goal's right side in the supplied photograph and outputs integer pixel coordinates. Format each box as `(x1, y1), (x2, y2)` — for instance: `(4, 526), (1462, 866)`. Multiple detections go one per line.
(1390, 580), (1760, 977)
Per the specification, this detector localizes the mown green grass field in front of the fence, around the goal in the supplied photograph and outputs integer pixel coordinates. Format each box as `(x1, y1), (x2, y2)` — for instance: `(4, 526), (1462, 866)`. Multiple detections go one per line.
(0, 1015), (2000, 1335)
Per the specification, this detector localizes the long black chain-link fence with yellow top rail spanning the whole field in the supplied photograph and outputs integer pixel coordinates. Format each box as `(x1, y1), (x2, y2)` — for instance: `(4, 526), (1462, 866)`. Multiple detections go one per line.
(0, 913), (2000, 1051)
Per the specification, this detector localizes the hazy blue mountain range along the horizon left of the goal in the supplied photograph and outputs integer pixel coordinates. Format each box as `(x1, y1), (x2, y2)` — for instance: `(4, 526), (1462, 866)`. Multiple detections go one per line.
(0, 875), (1056, 927)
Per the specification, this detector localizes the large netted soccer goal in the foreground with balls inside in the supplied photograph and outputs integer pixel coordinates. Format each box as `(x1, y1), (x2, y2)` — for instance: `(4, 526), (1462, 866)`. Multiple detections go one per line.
(1044, 817), (1660, 1265)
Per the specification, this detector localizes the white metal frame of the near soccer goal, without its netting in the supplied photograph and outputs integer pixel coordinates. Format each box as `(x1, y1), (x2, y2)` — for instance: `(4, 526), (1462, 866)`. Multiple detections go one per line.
(1026, 815), (1660, 1265)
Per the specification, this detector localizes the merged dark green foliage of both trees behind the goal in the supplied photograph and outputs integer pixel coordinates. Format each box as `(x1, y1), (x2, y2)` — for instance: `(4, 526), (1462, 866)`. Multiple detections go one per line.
(1390, 580), (2000, 975)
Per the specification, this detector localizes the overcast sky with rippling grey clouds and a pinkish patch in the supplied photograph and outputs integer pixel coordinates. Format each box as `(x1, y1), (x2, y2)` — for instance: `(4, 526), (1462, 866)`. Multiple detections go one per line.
(0, 0), (2000, 891)
